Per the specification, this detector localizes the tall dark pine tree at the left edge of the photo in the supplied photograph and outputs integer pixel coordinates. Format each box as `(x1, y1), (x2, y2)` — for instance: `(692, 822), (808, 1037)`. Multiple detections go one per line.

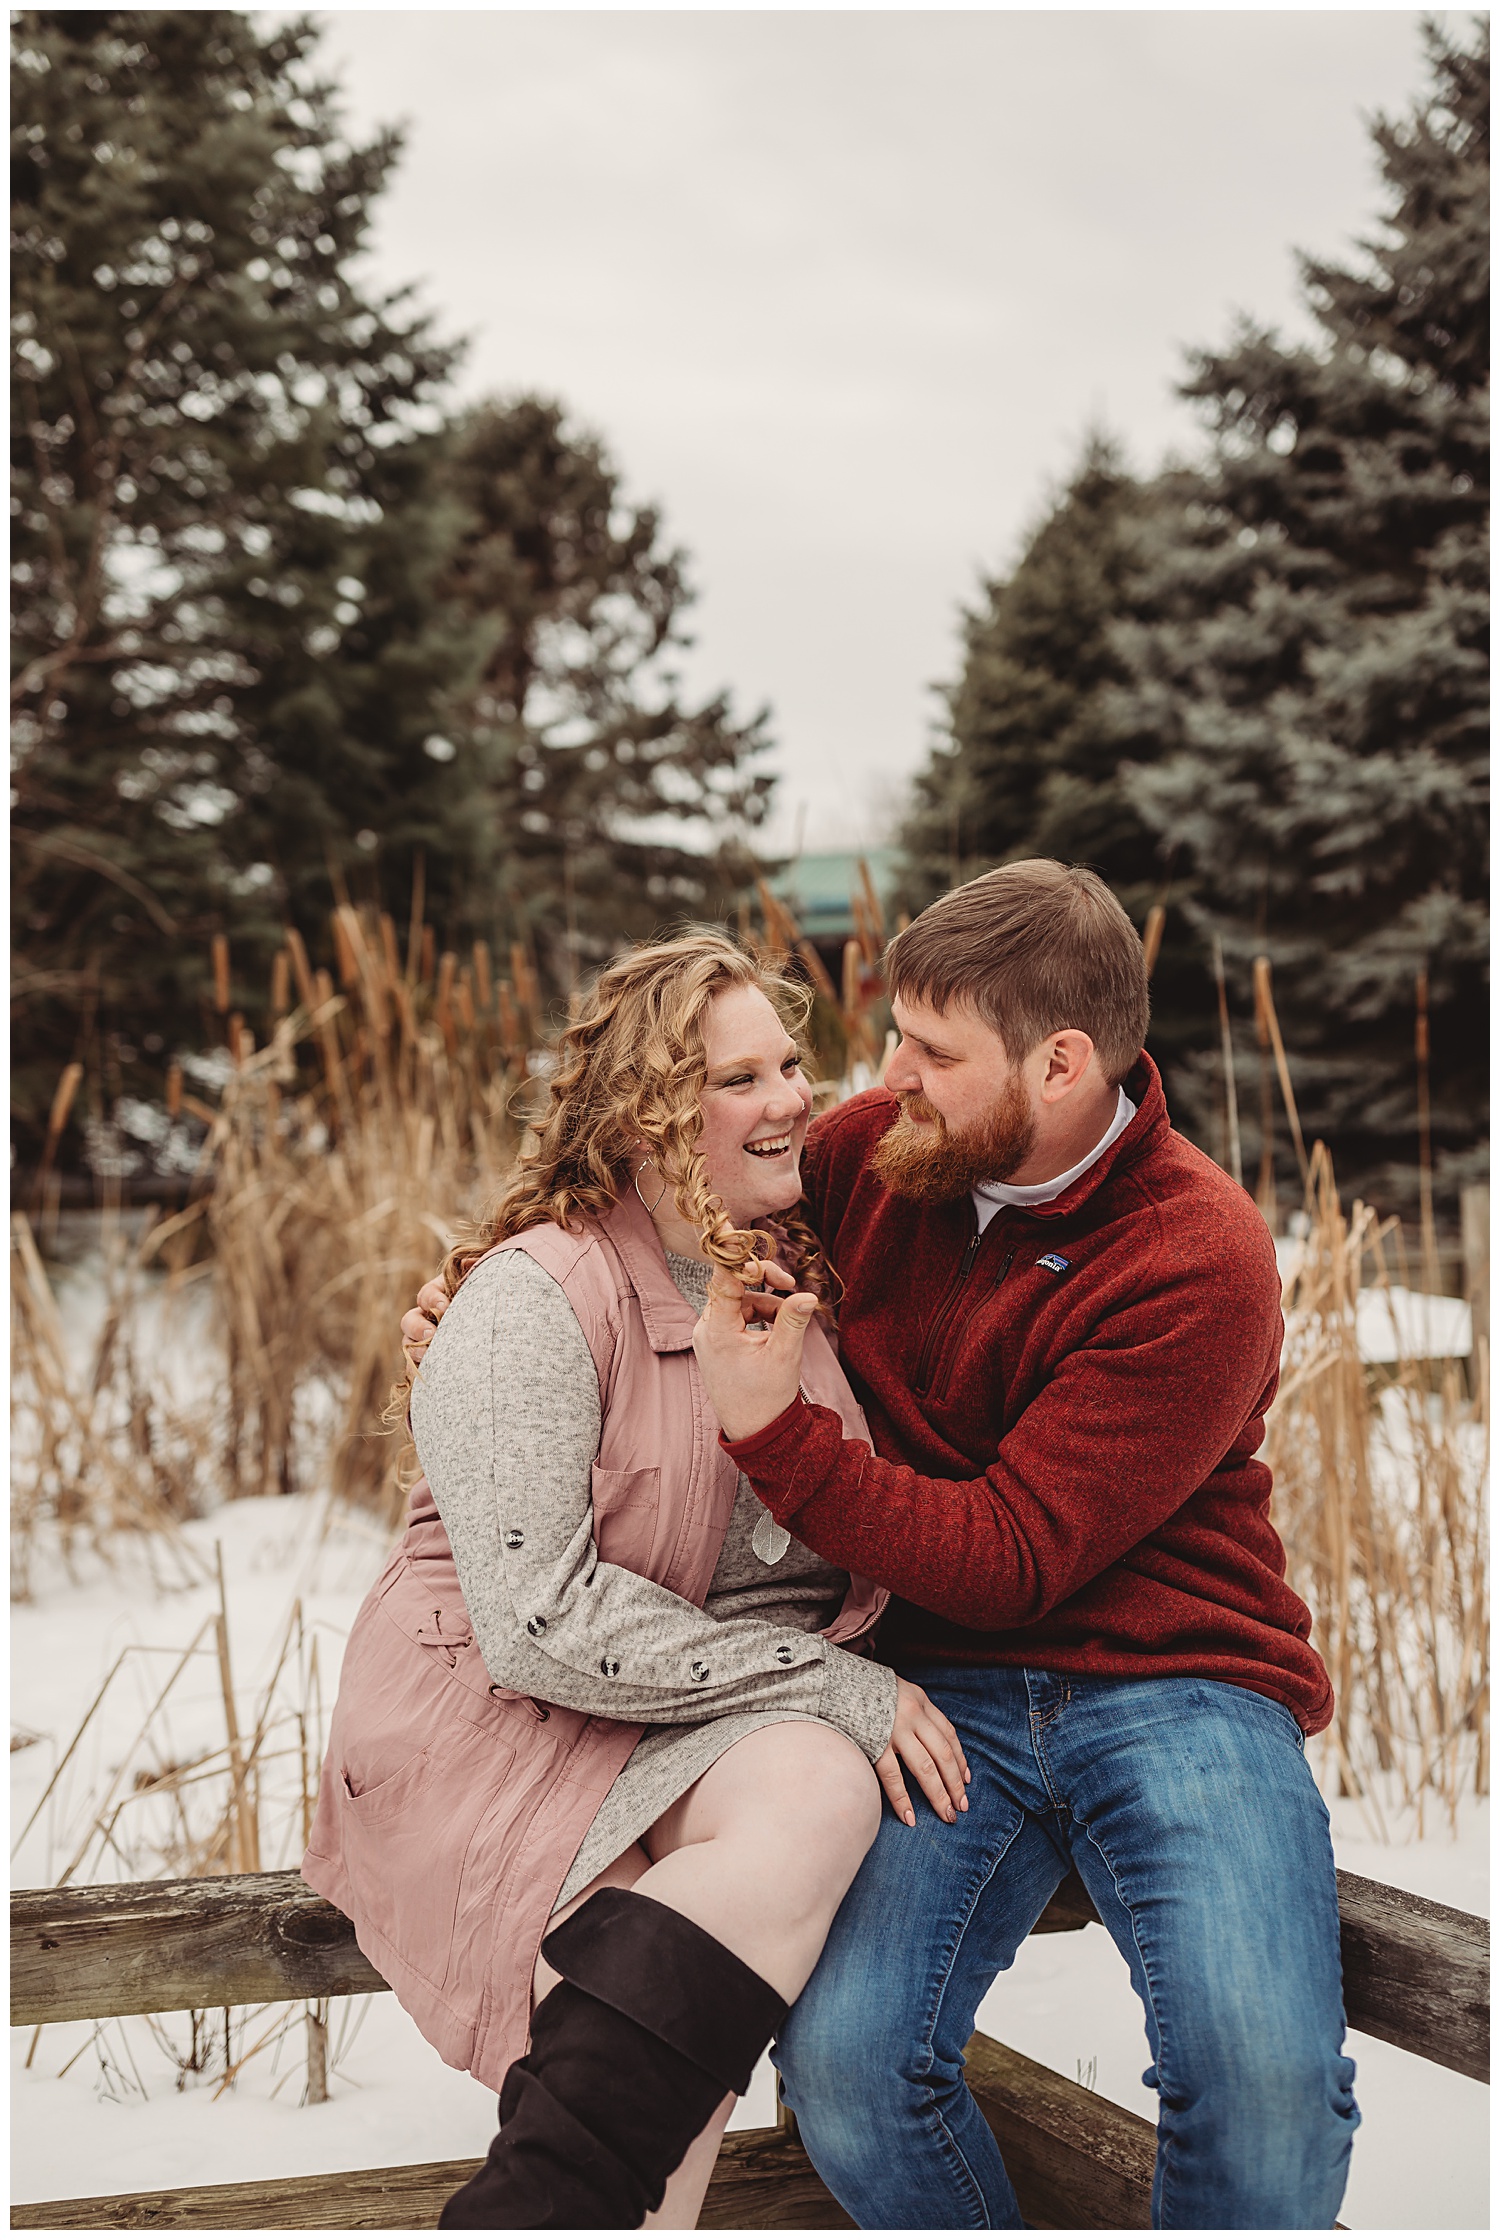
(11, 9), (481, 1138)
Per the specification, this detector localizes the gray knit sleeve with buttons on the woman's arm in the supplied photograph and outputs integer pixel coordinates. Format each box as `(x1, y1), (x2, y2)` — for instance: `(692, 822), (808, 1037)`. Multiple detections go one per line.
(412, 1252), (896, 1758)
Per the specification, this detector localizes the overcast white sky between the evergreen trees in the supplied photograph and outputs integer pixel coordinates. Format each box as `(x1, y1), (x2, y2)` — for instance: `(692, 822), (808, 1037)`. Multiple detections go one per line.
(304, 9), (1424, 847)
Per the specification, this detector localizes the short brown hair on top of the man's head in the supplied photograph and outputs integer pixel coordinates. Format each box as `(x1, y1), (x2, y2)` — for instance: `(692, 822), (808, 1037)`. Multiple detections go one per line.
(884, 856), (1151, 1086)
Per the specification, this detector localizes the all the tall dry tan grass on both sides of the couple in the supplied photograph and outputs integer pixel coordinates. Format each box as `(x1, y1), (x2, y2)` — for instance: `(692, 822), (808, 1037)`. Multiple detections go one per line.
(11, 878), (1489, 1808)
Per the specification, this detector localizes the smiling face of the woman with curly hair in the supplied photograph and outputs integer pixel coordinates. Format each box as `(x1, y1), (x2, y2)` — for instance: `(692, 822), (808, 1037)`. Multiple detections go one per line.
(699, 988), (813, 1228)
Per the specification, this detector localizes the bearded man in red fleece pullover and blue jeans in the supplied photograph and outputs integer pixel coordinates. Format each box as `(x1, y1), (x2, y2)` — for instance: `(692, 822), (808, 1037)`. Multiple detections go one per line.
(405, 860), (1359, 2231)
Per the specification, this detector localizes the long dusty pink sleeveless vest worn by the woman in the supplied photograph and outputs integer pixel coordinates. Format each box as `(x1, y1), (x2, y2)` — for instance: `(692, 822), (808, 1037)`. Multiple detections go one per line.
(302, 1196), (887, 2092)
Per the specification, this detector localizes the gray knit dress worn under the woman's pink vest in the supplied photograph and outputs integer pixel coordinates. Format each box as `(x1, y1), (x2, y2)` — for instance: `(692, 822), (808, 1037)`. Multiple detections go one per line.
(412, 1252), (896, 1906)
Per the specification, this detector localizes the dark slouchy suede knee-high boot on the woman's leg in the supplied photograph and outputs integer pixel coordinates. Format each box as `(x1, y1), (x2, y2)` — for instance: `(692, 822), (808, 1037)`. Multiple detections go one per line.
(439, 1891), (786, 2231)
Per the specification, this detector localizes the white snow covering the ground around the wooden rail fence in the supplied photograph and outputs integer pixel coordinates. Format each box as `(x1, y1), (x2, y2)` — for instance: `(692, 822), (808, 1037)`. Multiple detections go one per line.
(11, 1499), (1489, 2231)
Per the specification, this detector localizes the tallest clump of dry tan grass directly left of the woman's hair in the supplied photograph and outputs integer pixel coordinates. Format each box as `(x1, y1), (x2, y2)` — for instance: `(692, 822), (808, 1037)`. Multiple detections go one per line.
(204, 905), (535, 1516)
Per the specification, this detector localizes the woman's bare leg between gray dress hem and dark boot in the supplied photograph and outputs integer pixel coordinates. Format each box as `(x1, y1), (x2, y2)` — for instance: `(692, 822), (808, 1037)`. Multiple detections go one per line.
(533, 1720), (880, 2231)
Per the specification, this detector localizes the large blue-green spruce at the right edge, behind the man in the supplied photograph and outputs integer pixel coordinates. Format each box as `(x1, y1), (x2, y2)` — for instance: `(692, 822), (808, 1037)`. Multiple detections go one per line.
(1106, 29), (1489, 1205)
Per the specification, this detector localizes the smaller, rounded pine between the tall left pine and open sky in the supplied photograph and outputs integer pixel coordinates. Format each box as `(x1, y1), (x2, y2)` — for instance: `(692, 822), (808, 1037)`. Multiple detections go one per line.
(432, 396), (772, 988)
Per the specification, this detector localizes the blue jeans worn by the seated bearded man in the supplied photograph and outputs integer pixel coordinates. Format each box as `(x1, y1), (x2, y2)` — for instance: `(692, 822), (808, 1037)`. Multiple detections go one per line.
(777, 1664), (1359, 2231)
